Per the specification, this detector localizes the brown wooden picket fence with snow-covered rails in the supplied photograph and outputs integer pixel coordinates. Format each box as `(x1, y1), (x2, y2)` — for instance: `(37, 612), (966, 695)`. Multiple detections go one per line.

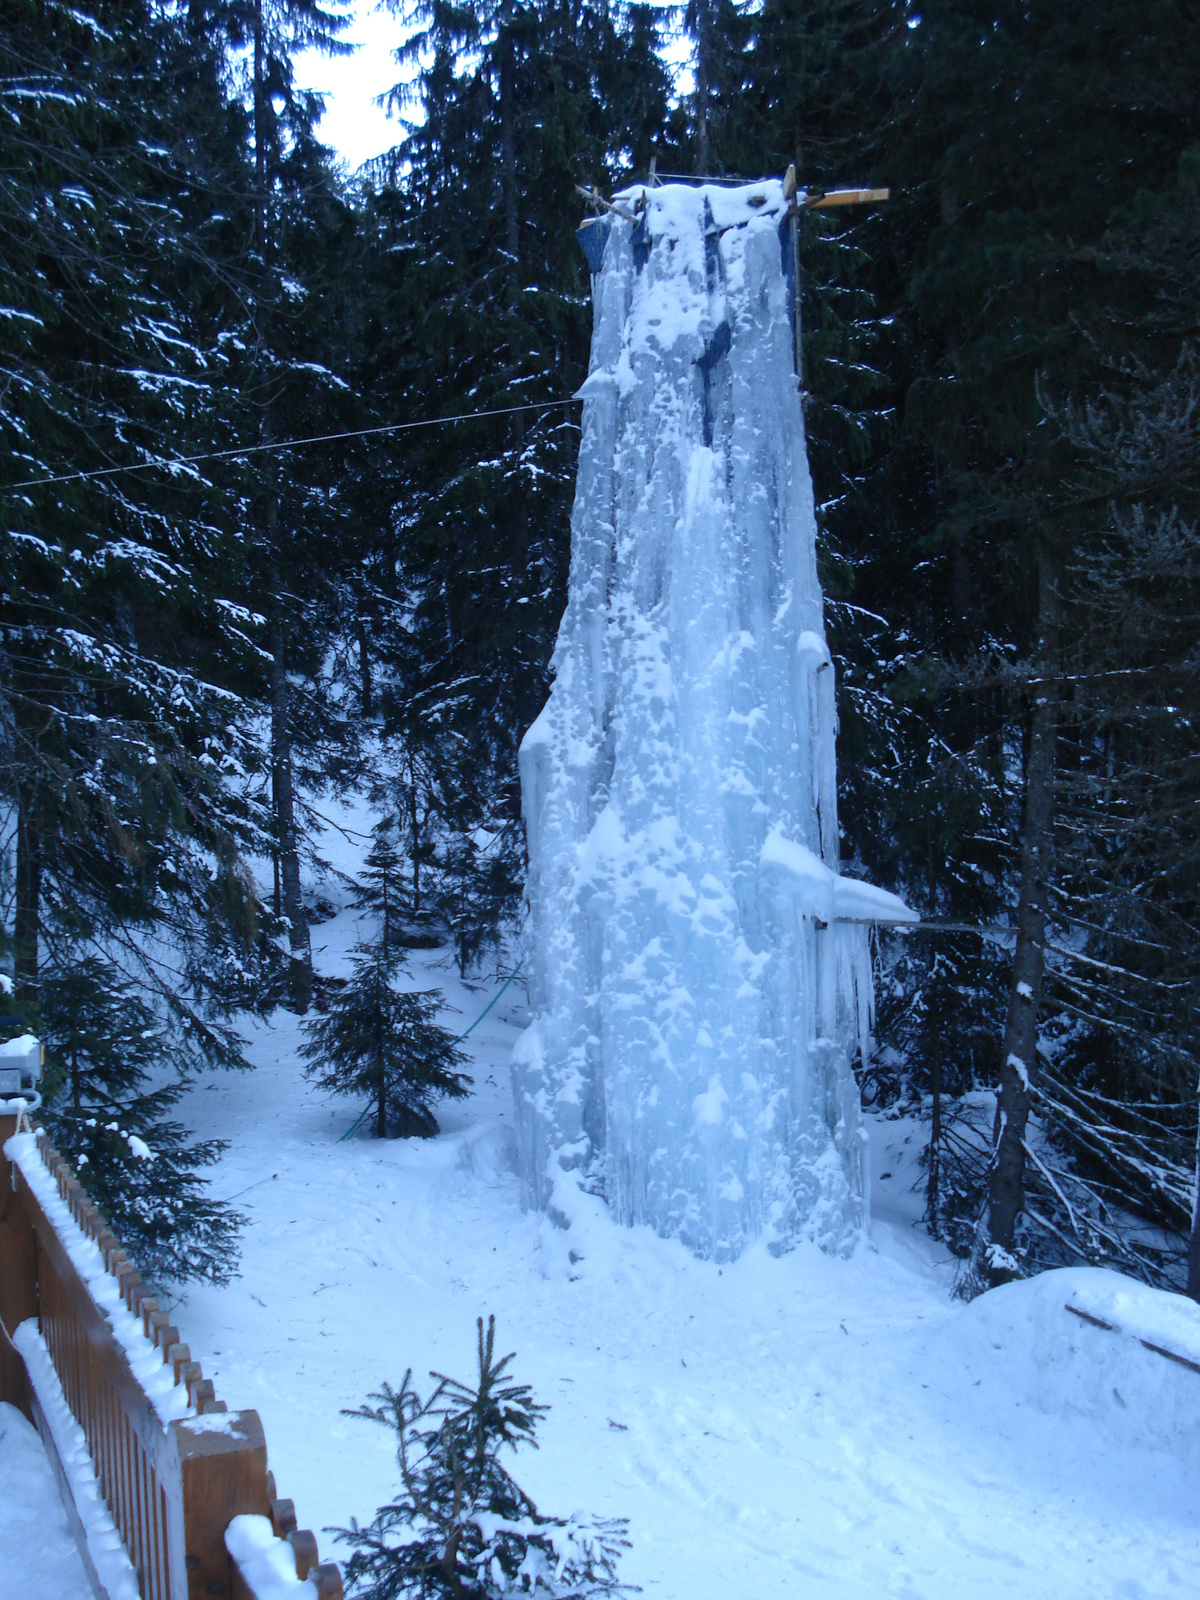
(0, 1117), (342, 1600)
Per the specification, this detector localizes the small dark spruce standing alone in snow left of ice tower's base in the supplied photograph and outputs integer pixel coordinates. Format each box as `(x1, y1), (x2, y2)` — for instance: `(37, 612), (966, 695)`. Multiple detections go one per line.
(301, 934), (472, 1139)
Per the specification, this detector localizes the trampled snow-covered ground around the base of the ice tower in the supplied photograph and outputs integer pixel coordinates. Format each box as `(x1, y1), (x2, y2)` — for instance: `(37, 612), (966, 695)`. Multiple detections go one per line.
(171, 918), (1200, 1600)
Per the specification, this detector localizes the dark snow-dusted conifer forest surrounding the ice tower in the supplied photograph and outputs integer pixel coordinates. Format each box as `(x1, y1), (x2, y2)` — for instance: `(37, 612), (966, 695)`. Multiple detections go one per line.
(0, 0), (1200, 1294)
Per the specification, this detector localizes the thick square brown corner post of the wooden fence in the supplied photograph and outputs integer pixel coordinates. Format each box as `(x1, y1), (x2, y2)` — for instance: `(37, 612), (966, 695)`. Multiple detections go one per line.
(171, 1411), (270, 1600)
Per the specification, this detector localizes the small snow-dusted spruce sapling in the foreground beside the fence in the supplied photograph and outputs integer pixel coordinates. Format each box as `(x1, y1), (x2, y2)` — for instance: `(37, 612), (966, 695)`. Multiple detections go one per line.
(333, 1317), (632, 1600)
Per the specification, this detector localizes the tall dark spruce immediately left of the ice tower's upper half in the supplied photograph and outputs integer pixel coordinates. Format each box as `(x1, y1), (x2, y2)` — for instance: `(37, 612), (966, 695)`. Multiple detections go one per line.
(347, 0), (681, 962)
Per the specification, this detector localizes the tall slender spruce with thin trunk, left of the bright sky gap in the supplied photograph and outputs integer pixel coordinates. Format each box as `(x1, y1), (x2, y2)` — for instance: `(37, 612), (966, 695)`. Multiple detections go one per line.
(202, 0), (352, 1013)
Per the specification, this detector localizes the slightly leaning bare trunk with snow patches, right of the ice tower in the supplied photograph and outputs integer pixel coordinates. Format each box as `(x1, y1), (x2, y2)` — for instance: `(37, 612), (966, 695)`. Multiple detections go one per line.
(987, 554), (1058, 1285)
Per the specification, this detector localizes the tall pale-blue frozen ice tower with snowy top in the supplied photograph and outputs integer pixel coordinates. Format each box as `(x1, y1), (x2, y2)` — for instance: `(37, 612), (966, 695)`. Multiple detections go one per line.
(514, 182), (912, 1259)
